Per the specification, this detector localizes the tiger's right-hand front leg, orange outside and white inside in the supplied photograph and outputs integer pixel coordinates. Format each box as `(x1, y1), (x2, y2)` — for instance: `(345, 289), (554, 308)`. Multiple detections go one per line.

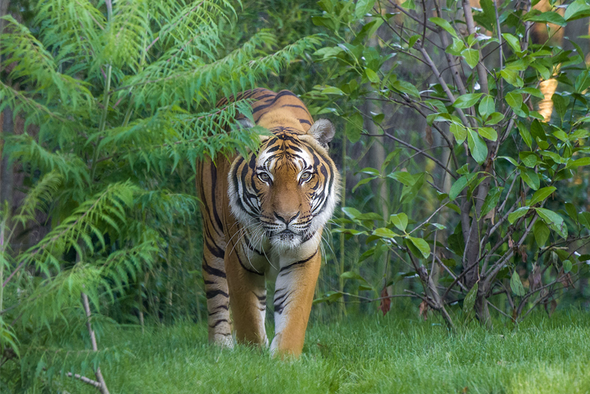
(270, 250), (321, 356)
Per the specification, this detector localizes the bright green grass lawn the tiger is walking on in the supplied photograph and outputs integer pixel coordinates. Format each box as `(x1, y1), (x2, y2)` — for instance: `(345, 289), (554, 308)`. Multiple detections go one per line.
(59, 311), (590, 394)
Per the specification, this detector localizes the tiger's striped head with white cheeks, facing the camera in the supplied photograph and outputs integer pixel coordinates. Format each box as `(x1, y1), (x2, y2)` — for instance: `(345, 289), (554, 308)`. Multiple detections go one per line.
(228, 119), (340, 250)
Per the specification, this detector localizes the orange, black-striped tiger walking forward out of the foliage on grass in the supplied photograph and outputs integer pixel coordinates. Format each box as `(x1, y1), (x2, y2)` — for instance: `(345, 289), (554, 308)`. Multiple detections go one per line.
(196, 88), (341, 357)
